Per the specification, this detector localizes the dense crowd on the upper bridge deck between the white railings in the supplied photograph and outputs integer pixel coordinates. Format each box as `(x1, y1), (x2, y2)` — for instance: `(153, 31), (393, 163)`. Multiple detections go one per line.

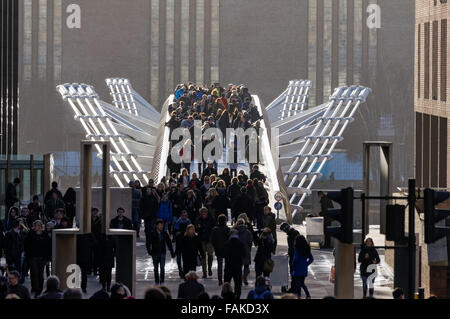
(166, 83), (262, 176)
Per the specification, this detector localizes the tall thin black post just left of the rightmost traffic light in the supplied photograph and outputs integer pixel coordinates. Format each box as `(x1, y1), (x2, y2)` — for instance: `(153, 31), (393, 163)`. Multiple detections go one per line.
(408, 179), (416, 299)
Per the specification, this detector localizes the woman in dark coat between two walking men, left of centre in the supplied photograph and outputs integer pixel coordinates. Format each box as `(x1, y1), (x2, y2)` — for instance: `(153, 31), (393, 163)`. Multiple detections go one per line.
(181, 224), (205, 274)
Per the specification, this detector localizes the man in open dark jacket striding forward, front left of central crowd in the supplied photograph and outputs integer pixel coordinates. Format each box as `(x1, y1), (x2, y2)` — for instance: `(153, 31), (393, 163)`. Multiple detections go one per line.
(146, 219), (175, 285)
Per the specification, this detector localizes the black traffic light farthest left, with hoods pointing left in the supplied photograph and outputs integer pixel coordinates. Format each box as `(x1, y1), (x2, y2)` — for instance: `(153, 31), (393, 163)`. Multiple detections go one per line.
(325, 187), (353, 244)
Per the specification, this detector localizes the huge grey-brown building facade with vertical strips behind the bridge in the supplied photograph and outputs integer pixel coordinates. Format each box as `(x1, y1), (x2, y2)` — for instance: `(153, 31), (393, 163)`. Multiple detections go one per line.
(10, 0), (414, 195)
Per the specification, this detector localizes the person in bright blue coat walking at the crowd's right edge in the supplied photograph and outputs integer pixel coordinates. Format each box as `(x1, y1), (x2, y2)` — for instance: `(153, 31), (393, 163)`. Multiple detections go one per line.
(292, 235), (314, 299)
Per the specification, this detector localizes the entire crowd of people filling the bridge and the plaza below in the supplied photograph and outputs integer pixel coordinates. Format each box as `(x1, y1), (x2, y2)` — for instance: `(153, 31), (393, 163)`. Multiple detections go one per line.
(0, 83), (414, 299)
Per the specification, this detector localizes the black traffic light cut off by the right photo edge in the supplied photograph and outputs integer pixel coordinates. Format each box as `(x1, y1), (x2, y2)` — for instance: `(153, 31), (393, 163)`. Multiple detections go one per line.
(424, 188), (450, 244)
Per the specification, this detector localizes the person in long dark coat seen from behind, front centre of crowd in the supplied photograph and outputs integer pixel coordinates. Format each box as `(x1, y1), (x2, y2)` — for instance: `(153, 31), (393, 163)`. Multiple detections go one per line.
(224, 229), (247, 299)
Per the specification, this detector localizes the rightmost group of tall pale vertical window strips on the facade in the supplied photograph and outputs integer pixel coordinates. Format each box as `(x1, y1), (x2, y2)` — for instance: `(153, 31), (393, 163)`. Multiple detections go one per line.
(308, 0), (378, 105)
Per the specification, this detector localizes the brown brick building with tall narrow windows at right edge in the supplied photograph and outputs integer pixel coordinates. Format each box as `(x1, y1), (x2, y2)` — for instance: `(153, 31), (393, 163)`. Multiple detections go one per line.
(414, 0), (450, 297)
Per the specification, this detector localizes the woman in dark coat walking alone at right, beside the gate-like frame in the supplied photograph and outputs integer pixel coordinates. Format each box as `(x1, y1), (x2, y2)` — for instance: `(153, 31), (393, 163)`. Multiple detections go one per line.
(358, 237), (380, 298)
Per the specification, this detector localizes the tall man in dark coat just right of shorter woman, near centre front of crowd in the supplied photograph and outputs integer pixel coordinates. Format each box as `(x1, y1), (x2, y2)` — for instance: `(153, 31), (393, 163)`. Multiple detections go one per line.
(195, 207), (216, 278)
